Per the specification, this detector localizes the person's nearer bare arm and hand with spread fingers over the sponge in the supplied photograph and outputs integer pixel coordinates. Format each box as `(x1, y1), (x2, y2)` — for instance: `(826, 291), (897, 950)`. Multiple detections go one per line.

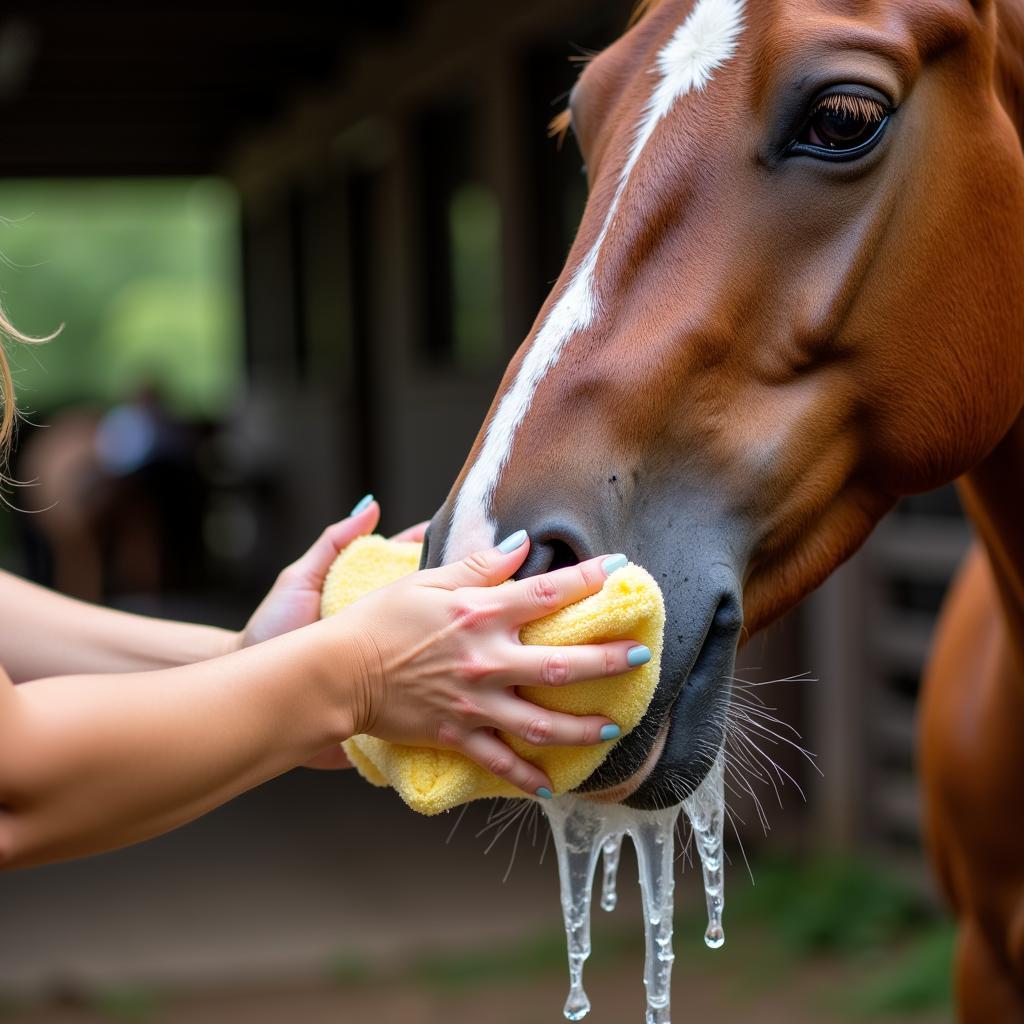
(0, 543), (633, 866)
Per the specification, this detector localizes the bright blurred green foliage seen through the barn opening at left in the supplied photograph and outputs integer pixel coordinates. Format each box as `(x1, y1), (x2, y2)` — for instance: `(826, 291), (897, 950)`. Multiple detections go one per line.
(0, 179), (242, 416)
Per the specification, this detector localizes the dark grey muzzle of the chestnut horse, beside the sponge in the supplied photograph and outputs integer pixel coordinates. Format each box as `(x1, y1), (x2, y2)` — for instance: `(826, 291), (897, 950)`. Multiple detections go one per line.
(424, 501), (745, 810)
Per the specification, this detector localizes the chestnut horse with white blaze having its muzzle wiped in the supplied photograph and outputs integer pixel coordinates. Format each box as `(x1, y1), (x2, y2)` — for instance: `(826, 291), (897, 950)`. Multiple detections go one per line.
(427, 0), (1024, 1024)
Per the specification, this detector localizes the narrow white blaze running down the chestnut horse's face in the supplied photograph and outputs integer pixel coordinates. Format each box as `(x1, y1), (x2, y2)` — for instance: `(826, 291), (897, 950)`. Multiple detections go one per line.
(444, 0), (743, 561)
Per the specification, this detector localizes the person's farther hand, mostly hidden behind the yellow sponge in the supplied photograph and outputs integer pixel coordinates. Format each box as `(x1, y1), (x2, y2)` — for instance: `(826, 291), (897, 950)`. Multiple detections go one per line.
(239, 495), (427, 648)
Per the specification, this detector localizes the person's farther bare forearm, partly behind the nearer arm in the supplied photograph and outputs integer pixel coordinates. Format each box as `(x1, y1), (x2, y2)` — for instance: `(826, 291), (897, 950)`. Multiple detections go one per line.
(0, 572), (238, 683)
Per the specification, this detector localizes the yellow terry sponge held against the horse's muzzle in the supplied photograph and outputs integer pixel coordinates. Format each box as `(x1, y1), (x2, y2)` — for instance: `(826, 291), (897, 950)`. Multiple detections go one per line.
(321, 537), (665, 814)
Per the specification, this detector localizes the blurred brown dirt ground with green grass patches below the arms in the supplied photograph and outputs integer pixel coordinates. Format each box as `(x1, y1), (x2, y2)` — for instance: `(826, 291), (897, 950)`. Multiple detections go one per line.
(0, 773), (952, 1024)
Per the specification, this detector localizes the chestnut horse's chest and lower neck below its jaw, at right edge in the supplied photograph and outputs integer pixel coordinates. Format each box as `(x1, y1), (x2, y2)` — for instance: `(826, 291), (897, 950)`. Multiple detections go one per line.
(920, 418), (1024, 1024)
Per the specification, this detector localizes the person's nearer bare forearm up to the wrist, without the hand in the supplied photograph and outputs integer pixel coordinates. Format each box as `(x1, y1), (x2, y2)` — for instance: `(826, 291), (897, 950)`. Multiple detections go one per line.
(0, 624), (360, 866)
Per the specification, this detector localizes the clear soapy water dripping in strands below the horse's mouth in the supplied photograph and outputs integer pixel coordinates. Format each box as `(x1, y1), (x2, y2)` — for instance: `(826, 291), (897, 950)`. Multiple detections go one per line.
(544, 752), (725, 1024)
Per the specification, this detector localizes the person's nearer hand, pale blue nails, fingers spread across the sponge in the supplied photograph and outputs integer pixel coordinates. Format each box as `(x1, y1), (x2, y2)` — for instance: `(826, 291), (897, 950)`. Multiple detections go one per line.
(329, 531), (650, 797)
